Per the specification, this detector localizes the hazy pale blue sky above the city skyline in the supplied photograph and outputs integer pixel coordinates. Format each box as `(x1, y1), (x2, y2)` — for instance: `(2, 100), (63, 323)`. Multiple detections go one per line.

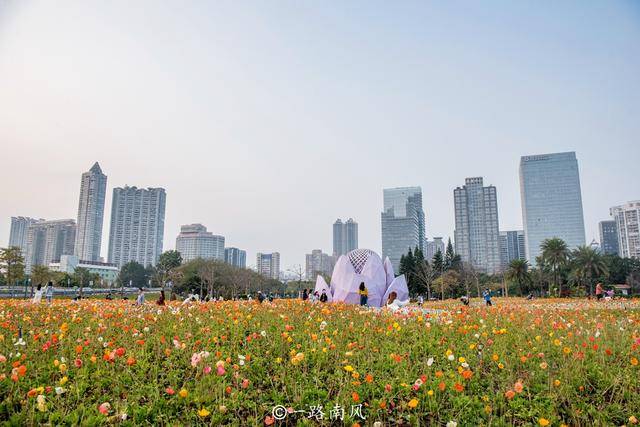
(0, 0), (640, 269)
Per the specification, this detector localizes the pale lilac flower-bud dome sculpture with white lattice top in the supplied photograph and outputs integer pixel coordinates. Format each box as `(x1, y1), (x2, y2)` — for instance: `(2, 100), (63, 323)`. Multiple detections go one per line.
(315, 249), (409, 307)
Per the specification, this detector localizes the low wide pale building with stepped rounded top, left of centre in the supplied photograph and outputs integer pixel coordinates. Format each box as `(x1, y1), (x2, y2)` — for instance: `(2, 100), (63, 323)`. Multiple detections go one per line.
(176, 224), (225, 261)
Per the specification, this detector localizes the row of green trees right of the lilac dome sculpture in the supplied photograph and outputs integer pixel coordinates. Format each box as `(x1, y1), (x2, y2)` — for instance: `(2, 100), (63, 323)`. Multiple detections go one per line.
(399, 238), (640, 299)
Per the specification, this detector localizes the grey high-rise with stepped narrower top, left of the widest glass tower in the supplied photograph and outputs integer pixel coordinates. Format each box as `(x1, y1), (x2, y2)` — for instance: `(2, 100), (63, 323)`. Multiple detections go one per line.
(453, 177), (500, 274)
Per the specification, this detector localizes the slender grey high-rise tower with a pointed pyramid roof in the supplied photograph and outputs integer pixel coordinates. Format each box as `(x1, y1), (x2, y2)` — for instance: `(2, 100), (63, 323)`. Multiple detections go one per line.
(75, 162), (107, 261)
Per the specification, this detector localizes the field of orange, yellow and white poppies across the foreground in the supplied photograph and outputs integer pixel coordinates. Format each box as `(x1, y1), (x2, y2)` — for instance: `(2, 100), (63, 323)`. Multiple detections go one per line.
(0, 299), (640, 426)
